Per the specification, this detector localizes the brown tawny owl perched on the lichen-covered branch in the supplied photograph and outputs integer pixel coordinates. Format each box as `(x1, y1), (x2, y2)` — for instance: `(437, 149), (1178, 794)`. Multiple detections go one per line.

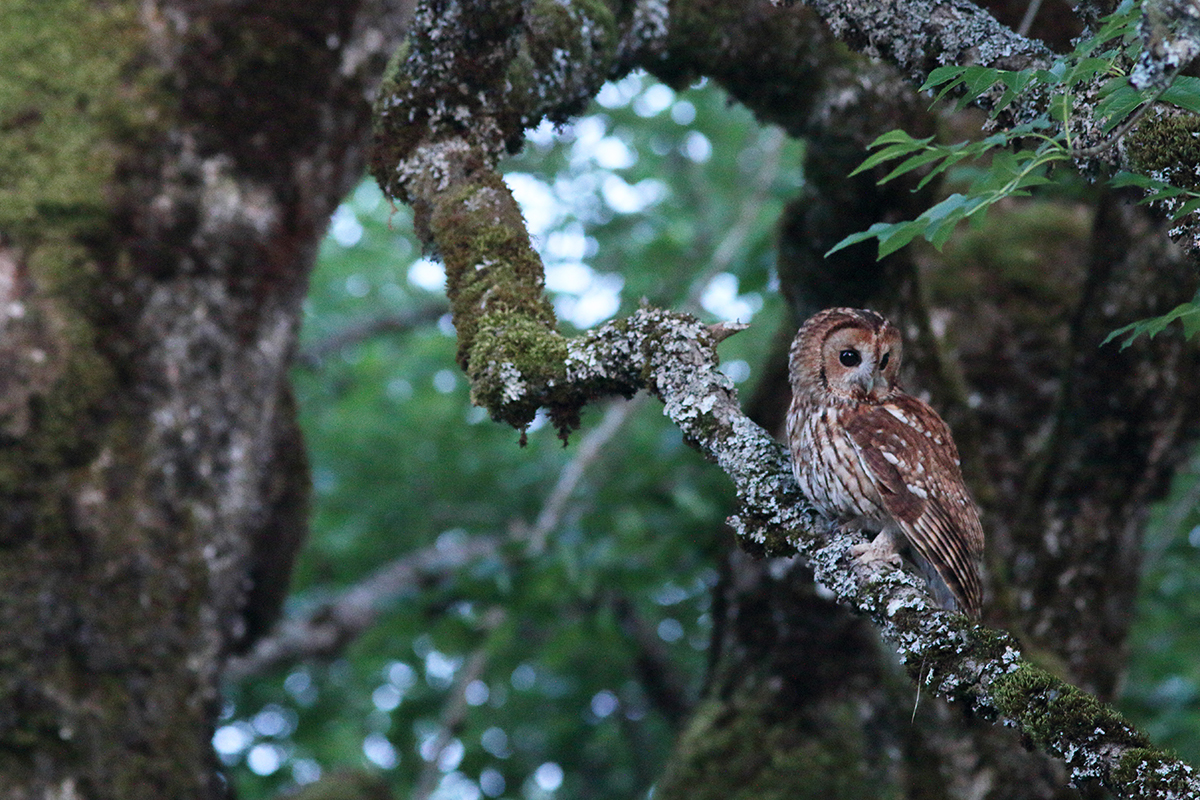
(787, 308), (983, 618)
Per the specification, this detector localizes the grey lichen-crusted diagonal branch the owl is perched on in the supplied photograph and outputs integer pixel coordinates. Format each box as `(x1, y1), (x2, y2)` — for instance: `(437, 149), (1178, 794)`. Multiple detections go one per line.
(518, 308), (1200, 798)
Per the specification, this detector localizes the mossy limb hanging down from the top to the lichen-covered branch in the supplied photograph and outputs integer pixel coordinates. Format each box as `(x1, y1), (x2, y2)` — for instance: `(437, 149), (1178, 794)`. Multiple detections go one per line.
(372, 0), (661, 435)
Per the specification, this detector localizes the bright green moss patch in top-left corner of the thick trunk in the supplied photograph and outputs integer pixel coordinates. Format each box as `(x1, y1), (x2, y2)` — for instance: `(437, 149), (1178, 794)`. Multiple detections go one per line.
(0, 0), (156, 242)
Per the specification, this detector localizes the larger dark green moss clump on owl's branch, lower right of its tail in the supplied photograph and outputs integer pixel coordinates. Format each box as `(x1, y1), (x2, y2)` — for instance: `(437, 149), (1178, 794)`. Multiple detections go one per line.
(991, 664), (1148, 748)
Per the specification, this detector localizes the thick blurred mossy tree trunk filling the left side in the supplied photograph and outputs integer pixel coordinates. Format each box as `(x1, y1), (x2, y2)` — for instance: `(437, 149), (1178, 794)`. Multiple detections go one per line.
(0, 0), (406, 799)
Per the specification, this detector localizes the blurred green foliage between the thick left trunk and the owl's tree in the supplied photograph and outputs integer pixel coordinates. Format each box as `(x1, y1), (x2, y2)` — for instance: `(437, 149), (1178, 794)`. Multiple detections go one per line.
(223, 76), (803, 799)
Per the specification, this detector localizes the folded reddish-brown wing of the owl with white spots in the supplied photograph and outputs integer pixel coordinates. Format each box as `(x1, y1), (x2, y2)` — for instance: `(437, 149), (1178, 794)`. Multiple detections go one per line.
(842, 395), (983, 616)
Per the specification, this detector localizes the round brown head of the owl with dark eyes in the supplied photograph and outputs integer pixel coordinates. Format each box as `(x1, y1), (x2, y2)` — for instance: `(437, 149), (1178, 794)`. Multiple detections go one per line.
(790, 308), (900, 403)
